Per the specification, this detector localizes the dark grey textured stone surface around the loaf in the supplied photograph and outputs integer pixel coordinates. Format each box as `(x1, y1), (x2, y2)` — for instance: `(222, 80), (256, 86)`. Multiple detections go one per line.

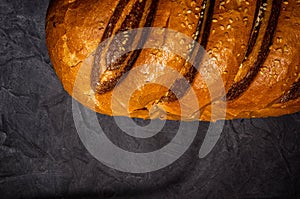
(0, 0), (300, 199)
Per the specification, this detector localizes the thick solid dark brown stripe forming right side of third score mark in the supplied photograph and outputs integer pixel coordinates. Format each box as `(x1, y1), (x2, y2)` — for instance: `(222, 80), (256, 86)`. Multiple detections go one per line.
(226, 0), (282, 100)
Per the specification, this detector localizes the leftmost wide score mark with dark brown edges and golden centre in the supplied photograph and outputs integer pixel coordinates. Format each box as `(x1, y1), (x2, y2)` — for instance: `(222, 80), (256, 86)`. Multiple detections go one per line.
(91, 0), (158, 94)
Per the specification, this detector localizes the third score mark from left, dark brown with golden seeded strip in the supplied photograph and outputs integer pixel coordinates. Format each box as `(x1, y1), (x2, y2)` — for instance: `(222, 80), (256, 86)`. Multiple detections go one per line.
(226, 0), (282, 101)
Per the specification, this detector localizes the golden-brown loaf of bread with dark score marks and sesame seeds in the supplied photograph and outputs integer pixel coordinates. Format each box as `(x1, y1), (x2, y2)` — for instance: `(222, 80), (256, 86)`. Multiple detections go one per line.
(46, 0), (300, 121)
